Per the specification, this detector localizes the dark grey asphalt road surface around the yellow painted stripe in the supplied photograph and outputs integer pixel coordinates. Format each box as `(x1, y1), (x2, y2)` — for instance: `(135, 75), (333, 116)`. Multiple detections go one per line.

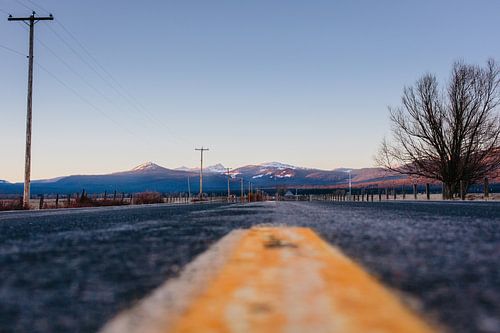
(0, 202), (500, 332)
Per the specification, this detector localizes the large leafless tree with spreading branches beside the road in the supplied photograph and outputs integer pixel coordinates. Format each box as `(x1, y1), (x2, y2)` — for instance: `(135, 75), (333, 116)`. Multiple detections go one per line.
(376, 60), (500, 198)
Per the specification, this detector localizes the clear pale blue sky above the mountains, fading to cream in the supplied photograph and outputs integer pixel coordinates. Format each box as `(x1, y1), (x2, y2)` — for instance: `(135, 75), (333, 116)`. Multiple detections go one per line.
(0, 0), (500, 181)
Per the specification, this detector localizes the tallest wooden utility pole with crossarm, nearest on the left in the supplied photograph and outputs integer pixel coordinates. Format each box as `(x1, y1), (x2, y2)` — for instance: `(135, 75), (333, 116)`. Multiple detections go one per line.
(8, 12), (54, 209)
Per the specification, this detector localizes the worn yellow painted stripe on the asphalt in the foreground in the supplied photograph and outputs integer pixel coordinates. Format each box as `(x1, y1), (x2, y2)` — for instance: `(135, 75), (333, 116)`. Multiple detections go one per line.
(100, 227), (434, 333)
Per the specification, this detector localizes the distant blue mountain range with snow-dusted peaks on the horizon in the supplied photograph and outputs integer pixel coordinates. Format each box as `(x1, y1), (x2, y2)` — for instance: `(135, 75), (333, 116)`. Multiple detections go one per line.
(0, 162), (496, 195)
